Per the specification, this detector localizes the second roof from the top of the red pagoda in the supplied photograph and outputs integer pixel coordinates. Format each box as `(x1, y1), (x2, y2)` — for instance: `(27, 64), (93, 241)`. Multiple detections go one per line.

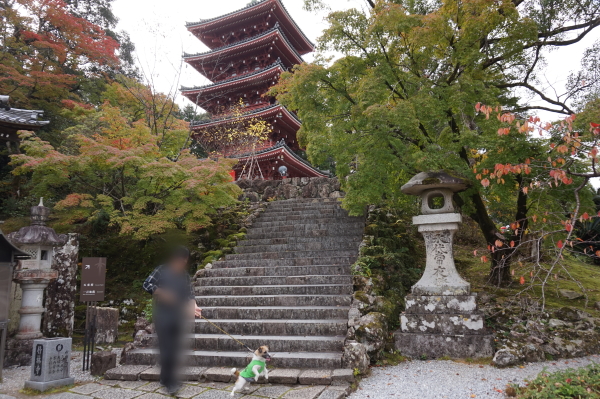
(183, 24), (303, 72)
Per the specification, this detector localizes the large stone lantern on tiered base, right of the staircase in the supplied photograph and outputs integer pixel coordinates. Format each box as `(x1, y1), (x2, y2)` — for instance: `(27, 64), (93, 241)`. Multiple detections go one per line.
(395, 171), (493, 358)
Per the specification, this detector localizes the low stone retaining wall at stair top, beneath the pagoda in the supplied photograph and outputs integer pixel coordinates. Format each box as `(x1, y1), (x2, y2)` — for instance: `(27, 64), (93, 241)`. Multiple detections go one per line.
(236, 177), (344, 202)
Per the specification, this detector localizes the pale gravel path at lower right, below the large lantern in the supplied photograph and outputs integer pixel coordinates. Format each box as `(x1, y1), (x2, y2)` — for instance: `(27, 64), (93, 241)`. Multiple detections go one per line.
(349, 355), (600, 399)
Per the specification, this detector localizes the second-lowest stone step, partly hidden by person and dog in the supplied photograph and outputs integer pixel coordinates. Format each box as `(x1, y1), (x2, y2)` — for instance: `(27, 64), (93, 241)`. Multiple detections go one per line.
(127, 349), (342, 369)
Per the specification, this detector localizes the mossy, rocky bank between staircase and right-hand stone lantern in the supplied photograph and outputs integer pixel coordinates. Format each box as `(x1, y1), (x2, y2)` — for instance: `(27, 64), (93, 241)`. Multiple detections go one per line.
(349, 208), (425, 362)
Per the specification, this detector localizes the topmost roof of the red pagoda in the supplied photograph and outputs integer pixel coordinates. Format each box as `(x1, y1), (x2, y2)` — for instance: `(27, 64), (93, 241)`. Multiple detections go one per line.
(186, 0), (315, 54)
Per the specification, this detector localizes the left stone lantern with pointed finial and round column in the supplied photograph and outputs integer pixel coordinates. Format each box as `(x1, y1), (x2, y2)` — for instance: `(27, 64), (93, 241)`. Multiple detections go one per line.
(8, 199), (67, 340)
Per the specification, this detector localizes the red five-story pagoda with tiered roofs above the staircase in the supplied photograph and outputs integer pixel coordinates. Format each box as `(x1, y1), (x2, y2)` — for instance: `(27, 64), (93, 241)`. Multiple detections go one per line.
(182, 0), (325, 179)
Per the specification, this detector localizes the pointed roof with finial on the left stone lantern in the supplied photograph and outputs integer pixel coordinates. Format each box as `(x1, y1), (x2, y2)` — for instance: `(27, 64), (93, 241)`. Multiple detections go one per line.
(8, 198), (67, 247)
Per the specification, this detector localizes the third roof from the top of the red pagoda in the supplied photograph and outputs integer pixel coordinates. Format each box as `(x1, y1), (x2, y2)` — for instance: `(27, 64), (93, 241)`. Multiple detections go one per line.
(181, 60), (286, 102)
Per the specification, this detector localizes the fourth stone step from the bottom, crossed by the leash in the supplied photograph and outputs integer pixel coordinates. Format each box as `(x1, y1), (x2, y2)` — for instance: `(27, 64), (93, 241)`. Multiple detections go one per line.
(194, 318), (348, 338)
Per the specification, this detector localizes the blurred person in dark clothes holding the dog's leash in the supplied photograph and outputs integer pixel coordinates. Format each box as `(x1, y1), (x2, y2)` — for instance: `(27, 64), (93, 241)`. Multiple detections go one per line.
(143, 247), (202, 395)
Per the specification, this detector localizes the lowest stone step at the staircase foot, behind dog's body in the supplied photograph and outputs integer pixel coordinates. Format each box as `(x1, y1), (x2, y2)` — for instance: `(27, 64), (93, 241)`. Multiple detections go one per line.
(104, 365), (354, 399)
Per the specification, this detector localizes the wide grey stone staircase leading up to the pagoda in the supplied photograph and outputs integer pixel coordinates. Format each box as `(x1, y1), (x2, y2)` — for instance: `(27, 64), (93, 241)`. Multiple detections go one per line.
(127, 199), (364, 370)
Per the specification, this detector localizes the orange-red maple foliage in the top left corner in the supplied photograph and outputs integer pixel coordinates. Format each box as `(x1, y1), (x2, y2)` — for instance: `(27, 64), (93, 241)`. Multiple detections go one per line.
(0, 0), (119, 107)
